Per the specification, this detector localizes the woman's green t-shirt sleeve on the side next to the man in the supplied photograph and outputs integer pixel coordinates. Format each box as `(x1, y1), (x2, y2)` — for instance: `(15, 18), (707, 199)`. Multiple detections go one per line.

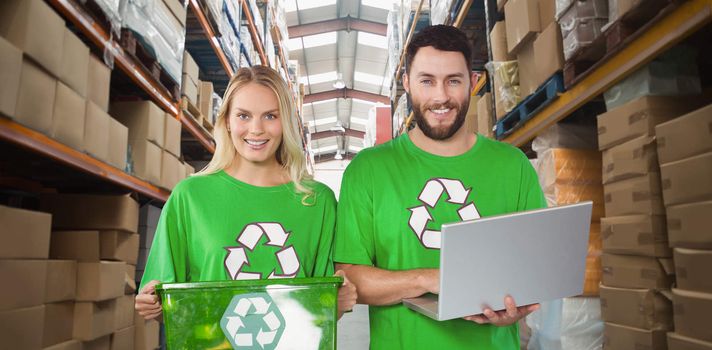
(311, 188), (336, 277)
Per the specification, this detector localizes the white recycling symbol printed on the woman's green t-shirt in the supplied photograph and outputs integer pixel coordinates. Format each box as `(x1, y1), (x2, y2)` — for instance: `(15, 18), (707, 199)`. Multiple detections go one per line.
(225, 222), (299, 280)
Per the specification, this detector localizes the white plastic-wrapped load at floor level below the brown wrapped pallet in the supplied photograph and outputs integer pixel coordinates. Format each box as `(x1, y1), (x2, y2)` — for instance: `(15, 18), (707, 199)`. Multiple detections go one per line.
(526, 298), (603, 350)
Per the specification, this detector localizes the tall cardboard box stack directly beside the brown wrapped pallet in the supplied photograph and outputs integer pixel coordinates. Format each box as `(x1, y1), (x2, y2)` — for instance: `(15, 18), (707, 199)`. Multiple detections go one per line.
(598, 96), (701, 349)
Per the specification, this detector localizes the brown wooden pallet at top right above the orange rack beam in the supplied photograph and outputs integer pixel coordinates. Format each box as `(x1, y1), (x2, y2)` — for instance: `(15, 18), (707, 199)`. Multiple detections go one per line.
(564, 0), (679, 89)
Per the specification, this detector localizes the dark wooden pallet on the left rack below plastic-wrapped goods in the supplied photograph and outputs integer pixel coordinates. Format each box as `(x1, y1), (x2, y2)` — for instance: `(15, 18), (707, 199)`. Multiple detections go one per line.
(119, 28), (180, 101)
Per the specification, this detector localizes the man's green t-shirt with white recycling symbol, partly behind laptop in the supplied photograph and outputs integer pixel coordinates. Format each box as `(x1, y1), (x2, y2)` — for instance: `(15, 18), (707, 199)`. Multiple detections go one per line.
(334, 134), (546, 350)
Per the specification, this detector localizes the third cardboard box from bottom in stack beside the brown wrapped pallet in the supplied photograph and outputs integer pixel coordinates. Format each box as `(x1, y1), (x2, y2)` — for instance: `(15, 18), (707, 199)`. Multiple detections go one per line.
(601, 254), (675, 289)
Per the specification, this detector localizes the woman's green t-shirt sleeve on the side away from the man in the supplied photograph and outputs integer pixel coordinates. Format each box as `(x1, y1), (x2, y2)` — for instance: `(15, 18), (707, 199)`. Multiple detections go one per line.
(139, 188), (188, 290)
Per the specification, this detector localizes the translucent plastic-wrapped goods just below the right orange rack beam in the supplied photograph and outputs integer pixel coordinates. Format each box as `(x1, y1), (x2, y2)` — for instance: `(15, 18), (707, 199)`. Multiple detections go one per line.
(603, 46), (702, 110)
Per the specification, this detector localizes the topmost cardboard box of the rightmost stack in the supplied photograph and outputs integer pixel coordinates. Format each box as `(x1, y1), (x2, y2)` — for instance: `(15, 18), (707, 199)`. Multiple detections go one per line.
(655, 105), (712, 164)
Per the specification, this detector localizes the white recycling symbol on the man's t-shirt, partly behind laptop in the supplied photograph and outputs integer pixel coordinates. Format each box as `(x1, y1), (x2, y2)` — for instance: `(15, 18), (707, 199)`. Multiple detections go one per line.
(408, 178), (480, 249)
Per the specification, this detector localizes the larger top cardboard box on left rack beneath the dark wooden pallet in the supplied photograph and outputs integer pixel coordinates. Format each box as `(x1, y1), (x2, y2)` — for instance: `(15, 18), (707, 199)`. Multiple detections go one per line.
(109, 101), (166, 147)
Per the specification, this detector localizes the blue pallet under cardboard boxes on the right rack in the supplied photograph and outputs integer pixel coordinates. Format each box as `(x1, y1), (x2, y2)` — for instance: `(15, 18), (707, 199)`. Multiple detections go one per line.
(495, 73), (564, 139)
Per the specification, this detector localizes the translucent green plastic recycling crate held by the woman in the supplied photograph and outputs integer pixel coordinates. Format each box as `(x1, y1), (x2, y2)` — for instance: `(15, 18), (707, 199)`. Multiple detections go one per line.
(156, 277), (343, 350)
